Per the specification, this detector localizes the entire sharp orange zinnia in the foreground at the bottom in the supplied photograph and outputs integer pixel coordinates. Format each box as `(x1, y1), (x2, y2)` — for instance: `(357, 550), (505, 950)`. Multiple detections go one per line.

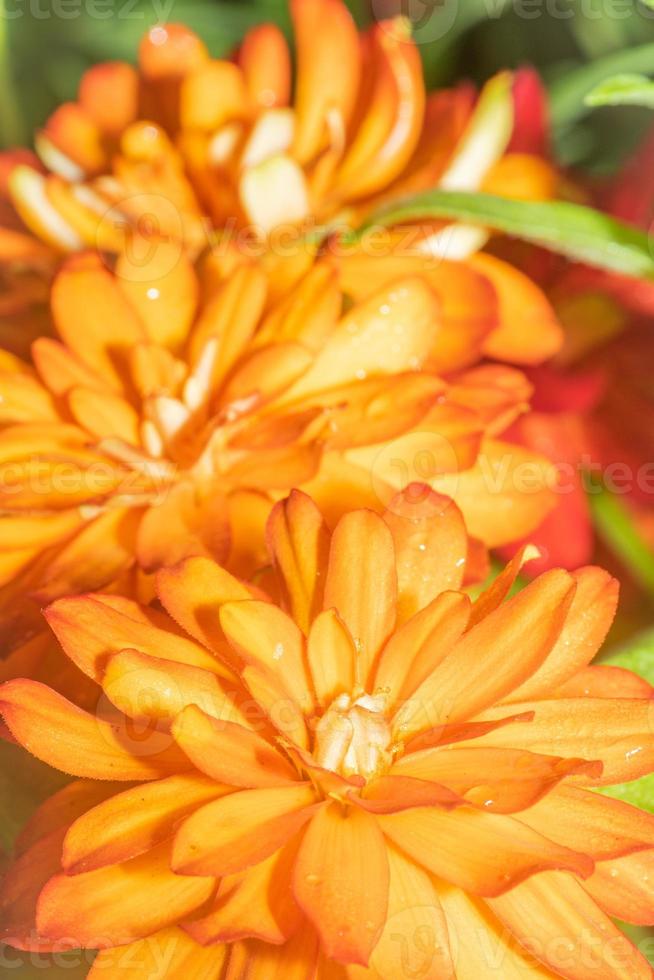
(0, 485), (654, 980)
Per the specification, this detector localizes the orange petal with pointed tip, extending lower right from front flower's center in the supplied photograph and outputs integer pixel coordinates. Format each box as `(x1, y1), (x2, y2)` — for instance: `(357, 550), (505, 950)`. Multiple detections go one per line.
(377, 807), (593, 896)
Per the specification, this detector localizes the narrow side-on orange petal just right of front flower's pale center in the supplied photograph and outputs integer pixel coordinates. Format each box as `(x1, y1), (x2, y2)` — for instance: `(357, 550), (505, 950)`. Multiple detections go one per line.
(391, 746), (601, 812)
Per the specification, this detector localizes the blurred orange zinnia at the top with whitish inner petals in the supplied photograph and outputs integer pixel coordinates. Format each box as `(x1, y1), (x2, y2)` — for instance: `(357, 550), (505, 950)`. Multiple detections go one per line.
(0, 0), (556, 314)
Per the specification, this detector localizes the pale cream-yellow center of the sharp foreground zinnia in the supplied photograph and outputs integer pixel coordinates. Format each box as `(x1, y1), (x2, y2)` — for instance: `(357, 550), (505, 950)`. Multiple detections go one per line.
(314, 694), (393, 779)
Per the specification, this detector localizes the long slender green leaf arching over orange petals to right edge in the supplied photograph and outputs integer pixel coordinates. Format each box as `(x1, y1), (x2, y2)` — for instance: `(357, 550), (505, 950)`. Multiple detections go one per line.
(359, 190), (654, 280)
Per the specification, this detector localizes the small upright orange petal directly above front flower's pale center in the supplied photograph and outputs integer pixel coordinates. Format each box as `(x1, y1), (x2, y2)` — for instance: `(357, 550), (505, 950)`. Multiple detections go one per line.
(307, 609), (357, 707)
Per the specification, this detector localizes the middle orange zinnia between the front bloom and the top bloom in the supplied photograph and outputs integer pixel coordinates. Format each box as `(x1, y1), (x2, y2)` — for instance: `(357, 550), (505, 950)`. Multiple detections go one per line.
(0, 230), (557, 646)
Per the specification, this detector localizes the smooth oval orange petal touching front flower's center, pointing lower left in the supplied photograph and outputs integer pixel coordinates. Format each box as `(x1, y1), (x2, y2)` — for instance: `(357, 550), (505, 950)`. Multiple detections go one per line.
(172, 783), (316, 876)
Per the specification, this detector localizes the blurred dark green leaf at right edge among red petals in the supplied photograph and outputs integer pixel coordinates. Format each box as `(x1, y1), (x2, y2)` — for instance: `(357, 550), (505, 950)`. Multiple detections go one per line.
(588, 484), (654, 596)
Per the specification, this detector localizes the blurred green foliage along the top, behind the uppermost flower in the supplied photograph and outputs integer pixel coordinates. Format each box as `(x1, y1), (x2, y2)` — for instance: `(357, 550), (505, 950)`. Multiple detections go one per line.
(0, 0), (654, 173)
